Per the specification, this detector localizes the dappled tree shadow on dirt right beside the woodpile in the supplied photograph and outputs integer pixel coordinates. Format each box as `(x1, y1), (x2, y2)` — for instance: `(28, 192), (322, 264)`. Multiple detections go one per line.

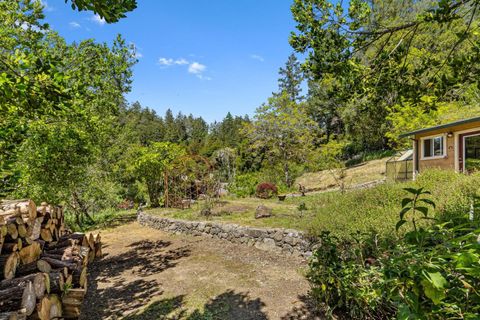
(80, 240), (190, 320)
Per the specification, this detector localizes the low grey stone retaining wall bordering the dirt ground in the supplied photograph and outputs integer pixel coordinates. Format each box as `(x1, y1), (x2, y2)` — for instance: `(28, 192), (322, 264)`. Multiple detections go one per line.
(137, 212), (313, 257)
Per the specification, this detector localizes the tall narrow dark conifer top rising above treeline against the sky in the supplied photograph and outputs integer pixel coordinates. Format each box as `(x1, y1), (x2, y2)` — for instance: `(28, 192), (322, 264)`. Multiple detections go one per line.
(278, 53), (304, 102)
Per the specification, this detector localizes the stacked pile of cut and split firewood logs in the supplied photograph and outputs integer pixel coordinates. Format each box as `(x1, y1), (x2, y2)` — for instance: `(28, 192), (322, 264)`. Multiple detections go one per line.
(0, 200), (102, 320)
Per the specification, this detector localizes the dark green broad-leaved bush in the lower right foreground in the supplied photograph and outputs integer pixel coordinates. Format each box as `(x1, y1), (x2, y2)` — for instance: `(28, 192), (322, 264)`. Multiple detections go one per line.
(307, 186), (480, 319)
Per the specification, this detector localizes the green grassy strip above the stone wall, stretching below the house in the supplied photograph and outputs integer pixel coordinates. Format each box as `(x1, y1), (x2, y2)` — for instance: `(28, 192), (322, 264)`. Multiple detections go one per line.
(147, 170), (480, 237)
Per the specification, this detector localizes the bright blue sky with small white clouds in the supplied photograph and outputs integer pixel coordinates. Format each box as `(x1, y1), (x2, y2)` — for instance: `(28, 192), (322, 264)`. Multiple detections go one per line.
(43, 0), (295, 122)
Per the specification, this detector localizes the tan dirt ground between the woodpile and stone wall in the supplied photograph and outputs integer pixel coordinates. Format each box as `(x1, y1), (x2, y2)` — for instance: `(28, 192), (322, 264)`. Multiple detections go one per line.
(82, 223), (313, 320)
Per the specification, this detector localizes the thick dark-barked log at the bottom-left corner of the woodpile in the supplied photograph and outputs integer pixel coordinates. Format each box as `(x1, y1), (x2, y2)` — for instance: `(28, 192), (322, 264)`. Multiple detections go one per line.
(0, 281), (36, 316)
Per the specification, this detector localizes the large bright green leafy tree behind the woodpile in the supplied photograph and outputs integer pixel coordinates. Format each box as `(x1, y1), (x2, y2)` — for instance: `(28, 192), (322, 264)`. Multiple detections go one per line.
(0, 1), (135, 218)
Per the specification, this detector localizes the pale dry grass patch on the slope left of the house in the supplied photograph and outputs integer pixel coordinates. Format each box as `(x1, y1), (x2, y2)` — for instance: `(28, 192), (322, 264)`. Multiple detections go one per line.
(296, 158), (390, 190)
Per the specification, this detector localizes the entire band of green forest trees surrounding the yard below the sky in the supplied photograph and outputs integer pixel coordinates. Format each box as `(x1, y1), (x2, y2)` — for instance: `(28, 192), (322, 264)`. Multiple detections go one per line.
(0, 0), (480, 219)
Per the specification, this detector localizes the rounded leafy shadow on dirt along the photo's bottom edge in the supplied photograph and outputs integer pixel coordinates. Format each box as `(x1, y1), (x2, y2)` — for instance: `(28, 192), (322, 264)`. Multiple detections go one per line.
(125, 290), (268, 320)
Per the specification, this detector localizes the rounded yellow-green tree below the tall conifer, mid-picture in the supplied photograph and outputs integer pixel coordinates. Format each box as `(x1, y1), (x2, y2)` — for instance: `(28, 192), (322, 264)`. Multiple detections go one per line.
(246, 92), (316, 187)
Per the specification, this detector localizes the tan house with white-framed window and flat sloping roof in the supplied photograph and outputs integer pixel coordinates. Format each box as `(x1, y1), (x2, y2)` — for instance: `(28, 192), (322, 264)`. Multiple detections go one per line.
(401, 117), (480, 173)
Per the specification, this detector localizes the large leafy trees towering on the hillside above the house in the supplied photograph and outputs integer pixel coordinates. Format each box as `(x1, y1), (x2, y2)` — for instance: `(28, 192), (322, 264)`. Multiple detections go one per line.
(290, 0), (480, 151)
